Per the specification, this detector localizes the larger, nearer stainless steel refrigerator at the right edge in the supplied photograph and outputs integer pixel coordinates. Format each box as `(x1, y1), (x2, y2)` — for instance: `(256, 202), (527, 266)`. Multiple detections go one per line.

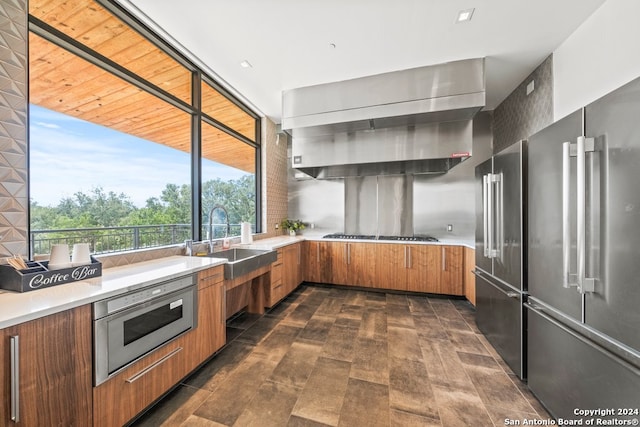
(525, 75), (640, 419)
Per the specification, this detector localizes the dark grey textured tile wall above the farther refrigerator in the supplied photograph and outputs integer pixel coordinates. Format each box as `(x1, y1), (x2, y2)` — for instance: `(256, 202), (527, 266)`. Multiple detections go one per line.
(493, 56), (553, 153)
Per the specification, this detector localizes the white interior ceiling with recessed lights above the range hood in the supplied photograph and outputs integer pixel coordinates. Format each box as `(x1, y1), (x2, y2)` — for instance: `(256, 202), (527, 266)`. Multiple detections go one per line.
(121, 0), (605, 123)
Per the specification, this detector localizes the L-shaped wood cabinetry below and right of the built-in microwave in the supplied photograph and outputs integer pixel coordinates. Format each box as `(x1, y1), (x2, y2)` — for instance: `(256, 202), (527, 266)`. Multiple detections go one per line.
(93, 266), (226, 427)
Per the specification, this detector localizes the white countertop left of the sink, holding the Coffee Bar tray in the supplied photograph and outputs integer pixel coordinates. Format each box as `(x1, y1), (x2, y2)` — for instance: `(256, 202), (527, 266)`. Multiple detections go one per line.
(0, 256), (225, 329)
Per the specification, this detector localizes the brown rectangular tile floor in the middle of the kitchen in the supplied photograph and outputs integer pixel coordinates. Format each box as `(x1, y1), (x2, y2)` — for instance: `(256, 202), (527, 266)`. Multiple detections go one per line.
(135, 285), (548, 427)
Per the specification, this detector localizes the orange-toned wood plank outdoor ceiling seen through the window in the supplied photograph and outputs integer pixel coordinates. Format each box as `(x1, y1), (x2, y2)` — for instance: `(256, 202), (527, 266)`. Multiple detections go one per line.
(29, 0), (256, 173)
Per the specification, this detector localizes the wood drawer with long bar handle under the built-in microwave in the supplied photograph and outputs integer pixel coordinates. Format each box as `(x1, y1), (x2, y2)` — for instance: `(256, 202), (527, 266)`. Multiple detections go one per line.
(93, 334), (190, 427)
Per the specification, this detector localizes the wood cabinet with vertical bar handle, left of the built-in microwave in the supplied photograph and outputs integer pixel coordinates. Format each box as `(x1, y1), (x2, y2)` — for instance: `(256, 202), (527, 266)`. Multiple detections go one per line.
(0, 305), (93, 427)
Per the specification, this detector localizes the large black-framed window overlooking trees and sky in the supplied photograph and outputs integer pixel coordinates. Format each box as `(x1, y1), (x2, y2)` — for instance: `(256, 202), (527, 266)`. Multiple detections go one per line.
(29, 0), (260, 255)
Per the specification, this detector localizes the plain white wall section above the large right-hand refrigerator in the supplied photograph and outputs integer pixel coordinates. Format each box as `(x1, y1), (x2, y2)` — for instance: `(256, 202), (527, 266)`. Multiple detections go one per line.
(553, 0), (640, 121)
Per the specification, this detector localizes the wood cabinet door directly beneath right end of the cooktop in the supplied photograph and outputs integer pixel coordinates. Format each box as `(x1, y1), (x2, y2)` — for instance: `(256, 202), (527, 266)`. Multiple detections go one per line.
(405, 245), (442, 293)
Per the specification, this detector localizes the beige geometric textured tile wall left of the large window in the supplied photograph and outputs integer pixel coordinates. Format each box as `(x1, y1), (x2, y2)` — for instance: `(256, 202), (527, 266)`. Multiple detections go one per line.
(0, 0), (29, 257)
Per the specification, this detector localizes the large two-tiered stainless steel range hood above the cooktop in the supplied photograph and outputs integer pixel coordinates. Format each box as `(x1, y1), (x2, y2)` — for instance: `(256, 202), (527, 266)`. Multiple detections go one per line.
(282, 58), (485, 178)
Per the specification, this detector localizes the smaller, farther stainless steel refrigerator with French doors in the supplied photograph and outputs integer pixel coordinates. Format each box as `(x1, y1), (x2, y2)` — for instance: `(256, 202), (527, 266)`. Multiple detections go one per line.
(474, 141), (527, 378)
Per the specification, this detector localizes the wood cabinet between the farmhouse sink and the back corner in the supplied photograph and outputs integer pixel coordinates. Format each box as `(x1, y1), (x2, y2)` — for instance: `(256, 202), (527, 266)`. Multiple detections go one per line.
(265, 242), (304, 307)
